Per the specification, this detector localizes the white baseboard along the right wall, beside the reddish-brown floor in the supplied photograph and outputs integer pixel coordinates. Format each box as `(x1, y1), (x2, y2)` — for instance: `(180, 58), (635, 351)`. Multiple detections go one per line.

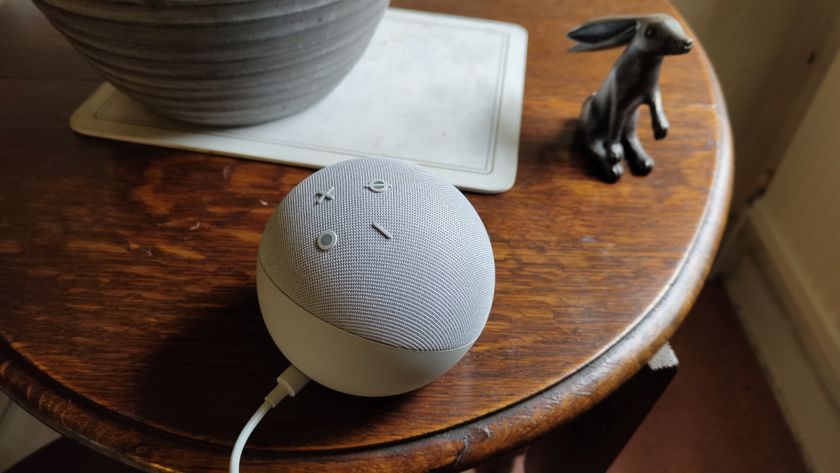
(724, 226), (840, 473)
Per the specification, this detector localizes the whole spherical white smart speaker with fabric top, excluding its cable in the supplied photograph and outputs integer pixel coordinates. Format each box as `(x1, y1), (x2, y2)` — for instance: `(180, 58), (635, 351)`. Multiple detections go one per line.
(257, 159), (495, 396)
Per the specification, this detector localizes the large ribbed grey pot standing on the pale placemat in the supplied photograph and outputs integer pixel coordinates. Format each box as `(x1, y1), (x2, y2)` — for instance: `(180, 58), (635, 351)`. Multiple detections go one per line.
(33, 0), (388, 126)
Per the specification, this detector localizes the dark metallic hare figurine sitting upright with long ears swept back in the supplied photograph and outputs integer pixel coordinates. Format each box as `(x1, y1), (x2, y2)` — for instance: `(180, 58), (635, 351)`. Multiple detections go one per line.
(567, 14), (692, 182)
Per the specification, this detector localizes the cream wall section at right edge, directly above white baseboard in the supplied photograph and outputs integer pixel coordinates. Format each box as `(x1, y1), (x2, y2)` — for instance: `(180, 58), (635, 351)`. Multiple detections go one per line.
(749, 43), (840, 400)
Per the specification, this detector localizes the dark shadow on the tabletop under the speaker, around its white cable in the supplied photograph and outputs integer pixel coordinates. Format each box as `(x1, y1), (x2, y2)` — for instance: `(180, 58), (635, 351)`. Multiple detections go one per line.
(137, 286), (411, 450)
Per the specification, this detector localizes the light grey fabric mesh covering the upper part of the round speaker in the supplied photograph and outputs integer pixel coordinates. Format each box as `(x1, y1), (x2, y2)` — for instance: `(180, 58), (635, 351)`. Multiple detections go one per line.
(260, 159), (495, 351)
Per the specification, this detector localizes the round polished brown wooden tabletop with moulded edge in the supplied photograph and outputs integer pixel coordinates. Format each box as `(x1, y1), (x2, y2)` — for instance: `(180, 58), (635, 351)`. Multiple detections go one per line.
(0, 0), (732, 472)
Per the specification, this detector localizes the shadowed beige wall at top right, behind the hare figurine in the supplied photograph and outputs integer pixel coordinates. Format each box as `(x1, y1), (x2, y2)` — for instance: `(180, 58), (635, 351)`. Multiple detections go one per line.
(665, 0), (840, 214)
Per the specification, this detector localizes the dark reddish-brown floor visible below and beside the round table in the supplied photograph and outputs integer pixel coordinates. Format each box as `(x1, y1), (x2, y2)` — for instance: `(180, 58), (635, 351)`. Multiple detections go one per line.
(9, 283), (807, 473)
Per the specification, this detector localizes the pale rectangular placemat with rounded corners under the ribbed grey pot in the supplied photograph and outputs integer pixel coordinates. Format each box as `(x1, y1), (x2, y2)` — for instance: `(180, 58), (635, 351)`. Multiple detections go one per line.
(70, 8), (528, 193)
